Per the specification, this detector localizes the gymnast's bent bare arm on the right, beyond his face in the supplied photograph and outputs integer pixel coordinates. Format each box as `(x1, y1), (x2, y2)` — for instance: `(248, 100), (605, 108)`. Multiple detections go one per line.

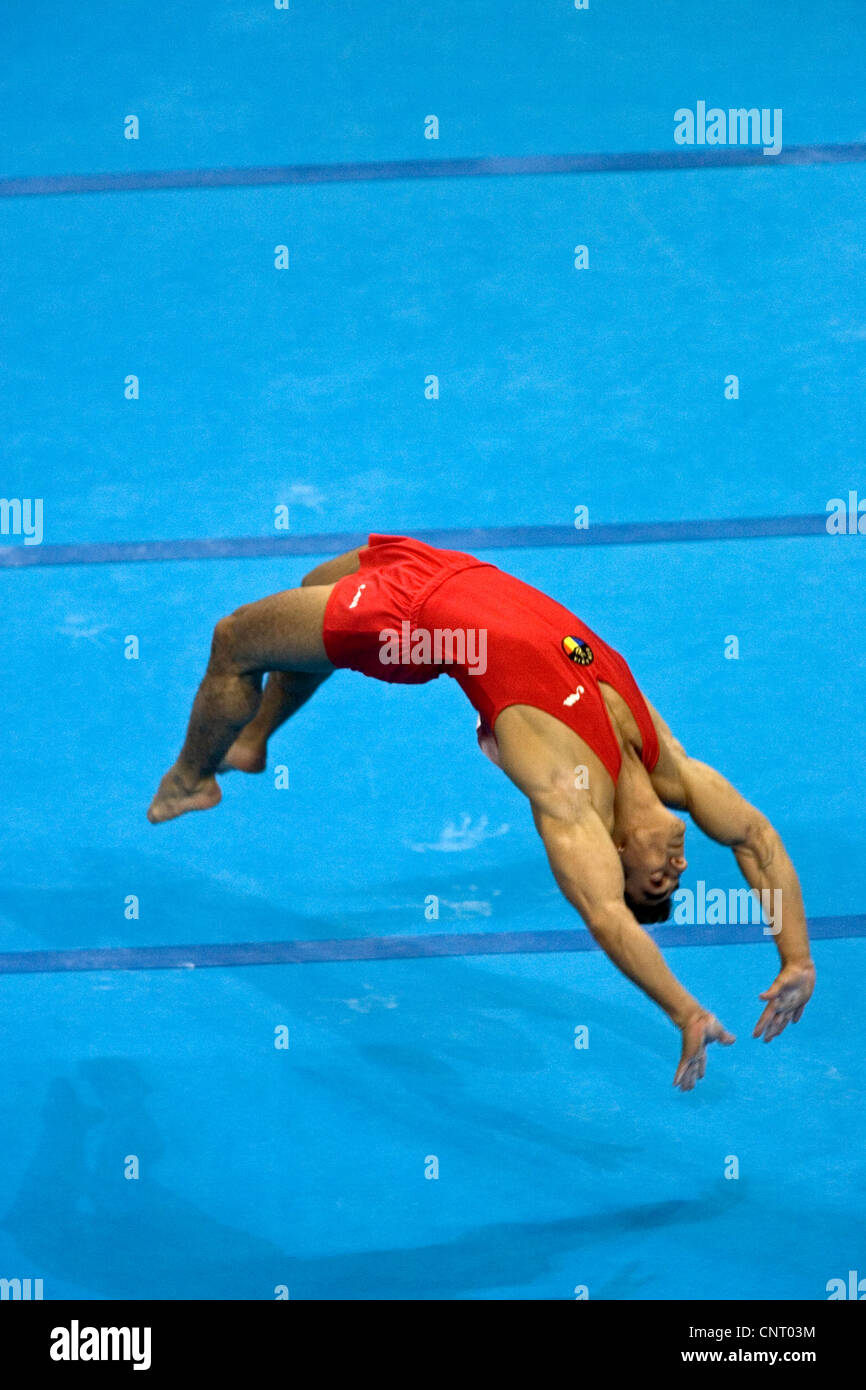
(677, 753), (815, 1043)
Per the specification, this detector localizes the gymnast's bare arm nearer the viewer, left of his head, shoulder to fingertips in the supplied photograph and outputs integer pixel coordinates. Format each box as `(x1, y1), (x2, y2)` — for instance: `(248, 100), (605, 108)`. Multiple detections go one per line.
(498, 706), (734, 1091)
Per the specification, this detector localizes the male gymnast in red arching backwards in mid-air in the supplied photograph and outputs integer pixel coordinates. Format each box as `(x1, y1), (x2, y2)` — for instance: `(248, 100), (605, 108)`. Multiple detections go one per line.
(147, 535), (815, 1091)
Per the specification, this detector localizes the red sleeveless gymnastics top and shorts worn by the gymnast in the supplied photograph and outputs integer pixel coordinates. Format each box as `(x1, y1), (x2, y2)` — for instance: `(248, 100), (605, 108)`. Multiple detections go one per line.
(322, 535), (659, 783)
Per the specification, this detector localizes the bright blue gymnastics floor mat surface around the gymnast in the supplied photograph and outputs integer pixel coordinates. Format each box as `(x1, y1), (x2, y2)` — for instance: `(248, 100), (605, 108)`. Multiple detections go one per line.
(0, 0), (866, 1300)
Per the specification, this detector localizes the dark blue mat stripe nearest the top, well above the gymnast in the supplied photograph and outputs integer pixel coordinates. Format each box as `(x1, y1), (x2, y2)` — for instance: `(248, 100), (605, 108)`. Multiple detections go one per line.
(0, 143), (866, 197)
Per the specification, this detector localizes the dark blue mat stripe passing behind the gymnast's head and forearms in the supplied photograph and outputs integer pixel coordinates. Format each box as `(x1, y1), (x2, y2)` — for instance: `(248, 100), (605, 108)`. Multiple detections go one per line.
(0, 915), (866, 974)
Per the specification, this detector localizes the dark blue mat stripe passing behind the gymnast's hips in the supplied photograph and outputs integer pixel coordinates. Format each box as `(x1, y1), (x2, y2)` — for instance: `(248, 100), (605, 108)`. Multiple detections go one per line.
(0, 513), (835, 569)
